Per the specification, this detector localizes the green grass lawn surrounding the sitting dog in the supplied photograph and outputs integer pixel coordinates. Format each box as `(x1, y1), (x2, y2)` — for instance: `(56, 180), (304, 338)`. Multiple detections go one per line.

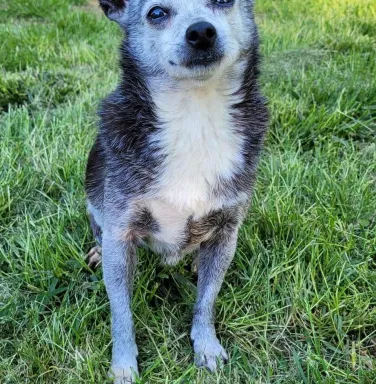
(0, 0), (376, 384)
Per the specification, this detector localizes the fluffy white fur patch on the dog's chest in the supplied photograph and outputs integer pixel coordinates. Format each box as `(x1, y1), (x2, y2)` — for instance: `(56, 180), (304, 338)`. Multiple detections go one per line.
(152, 80), (243, 216)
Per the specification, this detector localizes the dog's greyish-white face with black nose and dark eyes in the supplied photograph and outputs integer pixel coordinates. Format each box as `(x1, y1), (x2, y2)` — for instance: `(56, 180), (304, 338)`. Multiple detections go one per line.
(100, 0), (255, 80)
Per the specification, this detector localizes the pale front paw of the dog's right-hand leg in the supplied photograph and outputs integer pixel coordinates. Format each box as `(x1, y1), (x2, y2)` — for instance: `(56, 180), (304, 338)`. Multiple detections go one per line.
(193, 334), (228, 372)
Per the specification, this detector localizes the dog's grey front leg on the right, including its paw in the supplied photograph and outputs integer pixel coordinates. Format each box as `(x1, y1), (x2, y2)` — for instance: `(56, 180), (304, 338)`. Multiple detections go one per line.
(191, 230), (237, 371)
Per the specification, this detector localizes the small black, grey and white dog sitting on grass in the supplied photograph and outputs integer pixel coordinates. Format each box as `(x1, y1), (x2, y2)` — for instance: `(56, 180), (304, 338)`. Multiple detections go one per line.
(85, 0), (268, 383)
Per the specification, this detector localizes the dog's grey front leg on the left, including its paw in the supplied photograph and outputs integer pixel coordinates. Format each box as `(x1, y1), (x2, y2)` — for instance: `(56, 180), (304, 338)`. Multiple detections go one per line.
(102, 230), (138, 384)
